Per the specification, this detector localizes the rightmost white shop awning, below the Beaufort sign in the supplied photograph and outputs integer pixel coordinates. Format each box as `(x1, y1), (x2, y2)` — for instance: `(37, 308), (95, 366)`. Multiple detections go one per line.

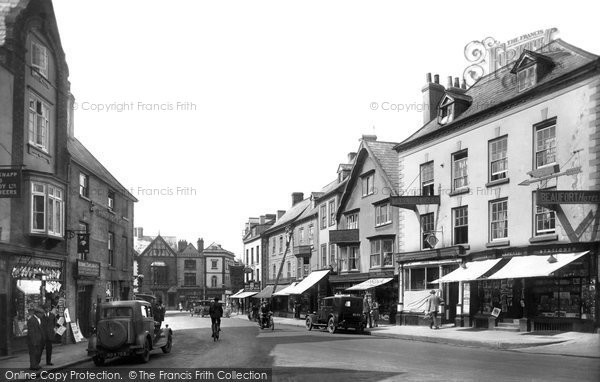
(487, 251), (589, 280)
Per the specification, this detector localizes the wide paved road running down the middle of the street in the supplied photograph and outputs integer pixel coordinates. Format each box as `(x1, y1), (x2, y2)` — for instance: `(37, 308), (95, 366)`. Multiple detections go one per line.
(78, 314), (600, 382)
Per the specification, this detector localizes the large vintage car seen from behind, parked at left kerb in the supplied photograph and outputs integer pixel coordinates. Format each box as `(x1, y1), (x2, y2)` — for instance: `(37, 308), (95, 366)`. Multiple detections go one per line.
(87, 300), (173, 366)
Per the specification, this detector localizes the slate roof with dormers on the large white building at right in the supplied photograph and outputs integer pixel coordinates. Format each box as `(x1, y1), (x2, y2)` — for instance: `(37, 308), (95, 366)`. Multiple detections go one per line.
(396, 39), (599, 149)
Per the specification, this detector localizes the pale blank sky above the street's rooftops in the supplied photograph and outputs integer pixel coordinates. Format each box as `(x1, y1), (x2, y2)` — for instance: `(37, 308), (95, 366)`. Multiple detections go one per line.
(54, 0), (600, 257)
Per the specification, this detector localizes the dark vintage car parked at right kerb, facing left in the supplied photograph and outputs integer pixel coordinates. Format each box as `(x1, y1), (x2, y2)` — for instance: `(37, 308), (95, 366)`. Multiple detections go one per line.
(306, 295), (367, 333)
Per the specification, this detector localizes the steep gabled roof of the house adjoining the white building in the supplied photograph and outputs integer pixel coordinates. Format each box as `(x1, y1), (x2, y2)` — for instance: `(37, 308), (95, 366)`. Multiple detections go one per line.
(337, 139), (400, 218)
